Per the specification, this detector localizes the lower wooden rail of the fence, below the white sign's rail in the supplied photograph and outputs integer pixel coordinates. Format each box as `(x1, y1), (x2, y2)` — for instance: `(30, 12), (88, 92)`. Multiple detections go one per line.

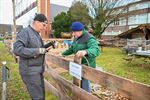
(45, 61), (99, 100)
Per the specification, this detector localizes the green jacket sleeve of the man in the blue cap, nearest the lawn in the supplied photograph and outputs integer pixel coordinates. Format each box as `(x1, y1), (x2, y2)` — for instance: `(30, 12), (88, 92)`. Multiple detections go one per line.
(86, 38), (100, 57)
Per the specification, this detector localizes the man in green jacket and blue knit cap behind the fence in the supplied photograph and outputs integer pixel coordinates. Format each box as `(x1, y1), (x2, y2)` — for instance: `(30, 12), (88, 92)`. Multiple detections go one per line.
(62, 21), (100, 92)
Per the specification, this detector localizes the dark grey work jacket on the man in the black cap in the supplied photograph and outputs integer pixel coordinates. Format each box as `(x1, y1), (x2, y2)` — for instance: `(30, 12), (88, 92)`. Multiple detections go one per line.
(13, 26), (44, 74)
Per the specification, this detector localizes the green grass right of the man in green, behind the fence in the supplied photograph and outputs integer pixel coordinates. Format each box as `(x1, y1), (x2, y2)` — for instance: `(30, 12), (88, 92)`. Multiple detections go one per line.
(97, 47), (150, 85)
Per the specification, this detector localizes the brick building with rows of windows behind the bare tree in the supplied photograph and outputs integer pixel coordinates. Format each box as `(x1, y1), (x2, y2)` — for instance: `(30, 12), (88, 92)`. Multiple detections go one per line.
(102, 0), (150, 39)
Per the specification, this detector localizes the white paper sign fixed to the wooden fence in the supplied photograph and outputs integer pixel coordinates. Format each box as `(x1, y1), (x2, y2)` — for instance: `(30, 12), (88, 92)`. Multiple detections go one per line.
(69, 62), (82, 80)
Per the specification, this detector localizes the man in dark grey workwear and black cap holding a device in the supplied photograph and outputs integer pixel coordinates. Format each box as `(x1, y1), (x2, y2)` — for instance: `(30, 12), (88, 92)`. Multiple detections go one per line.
(13, 14), (47, 100)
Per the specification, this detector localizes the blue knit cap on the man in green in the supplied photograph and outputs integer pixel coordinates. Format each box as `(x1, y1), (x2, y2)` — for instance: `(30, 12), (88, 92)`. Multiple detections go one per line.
(71, 22), (84, 31)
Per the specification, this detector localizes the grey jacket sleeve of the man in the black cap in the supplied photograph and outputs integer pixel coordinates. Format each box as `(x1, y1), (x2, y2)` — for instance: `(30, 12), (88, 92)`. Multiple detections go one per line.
(13, 30), (39, 58)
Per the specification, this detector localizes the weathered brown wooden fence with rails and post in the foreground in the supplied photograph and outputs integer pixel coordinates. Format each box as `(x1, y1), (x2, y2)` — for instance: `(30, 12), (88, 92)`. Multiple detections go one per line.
(45, 54), (150, 100)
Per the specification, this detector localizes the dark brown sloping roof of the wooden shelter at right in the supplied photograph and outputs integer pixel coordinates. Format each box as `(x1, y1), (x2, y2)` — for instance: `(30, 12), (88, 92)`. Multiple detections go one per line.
(115, 24), (150, 38)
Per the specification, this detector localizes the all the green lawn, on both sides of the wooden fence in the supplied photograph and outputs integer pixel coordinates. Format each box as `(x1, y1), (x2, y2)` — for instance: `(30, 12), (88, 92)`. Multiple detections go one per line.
(0, 43), (150, 100)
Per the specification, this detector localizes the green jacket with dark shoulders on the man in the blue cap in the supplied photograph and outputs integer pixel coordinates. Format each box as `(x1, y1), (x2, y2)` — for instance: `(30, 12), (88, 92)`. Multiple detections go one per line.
(62, 30), (100, 68)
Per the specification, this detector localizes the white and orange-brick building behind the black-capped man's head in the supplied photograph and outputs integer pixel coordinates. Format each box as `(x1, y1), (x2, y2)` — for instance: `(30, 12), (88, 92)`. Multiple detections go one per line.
(15, 0), (51, 38)
